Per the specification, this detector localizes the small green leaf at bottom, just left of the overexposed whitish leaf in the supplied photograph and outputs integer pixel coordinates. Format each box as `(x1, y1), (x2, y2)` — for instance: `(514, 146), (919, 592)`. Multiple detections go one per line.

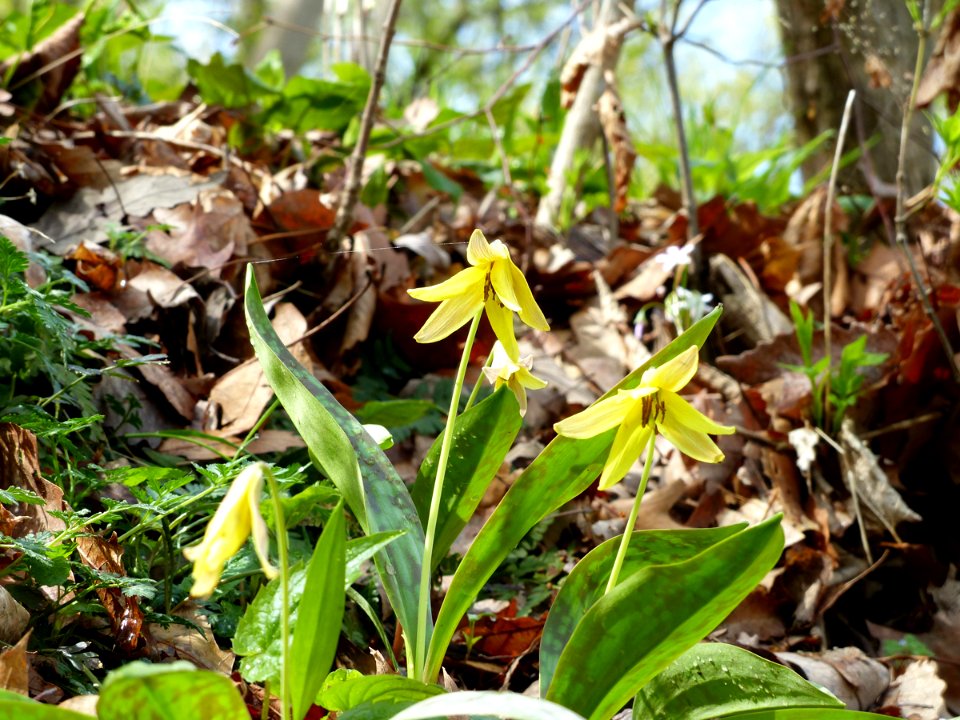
(317, 675), (443, 720)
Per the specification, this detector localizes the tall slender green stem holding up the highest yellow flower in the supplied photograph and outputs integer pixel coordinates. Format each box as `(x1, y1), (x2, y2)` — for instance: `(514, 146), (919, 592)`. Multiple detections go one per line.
(414, 310), (483, 683)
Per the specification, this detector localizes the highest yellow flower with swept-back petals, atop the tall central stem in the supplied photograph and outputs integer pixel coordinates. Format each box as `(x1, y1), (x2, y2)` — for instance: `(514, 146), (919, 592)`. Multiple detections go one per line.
(407, 230), (550, 360)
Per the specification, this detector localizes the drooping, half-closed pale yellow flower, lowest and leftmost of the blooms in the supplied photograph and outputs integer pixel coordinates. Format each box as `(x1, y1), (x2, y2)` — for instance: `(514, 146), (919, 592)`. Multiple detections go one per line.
(183, 462), (277, 597)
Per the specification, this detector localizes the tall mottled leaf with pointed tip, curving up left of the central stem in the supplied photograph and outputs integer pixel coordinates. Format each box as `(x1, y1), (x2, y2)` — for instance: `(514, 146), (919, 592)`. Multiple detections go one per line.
(244, 265), (431, 667)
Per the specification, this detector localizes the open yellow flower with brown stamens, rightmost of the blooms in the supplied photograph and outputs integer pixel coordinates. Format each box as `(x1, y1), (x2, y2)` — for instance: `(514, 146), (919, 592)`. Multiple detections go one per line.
(553, 347), (734, 490)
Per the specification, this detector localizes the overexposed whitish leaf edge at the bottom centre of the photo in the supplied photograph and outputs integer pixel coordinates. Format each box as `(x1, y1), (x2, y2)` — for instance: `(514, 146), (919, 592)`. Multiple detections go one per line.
(393, 691), (583, 720)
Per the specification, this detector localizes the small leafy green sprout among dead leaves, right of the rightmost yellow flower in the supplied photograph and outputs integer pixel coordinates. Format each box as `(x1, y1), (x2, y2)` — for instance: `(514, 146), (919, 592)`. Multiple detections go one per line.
(784, 301), (887, 433)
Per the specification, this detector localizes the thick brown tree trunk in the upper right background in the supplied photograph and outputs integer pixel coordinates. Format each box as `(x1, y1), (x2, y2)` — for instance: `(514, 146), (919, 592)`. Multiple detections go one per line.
(777, 0), (940, 196)
